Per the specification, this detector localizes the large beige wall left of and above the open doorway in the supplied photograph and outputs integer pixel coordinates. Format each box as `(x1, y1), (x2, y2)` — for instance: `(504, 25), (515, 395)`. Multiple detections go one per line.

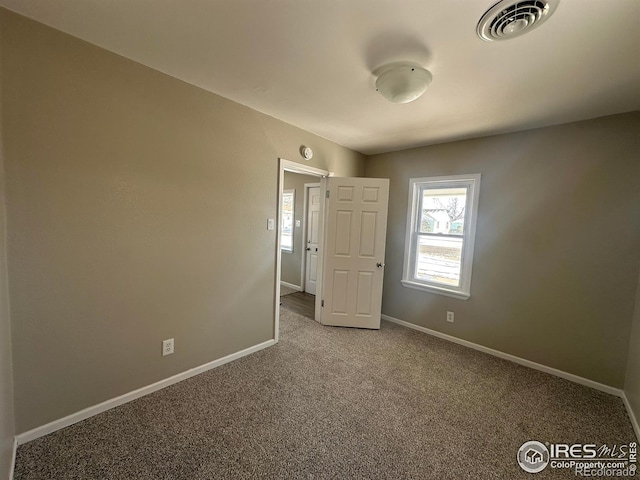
(0, 10), (364, 432)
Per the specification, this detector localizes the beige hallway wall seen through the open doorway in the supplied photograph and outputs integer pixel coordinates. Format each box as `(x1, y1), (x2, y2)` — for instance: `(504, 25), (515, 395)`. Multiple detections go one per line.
(280, 172), (320, 286)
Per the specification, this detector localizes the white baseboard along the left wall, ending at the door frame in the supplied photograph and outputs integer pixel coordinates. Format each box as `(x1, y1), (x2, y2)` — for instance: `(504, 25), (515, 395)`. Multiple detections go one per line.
(16, 340), (276, 445)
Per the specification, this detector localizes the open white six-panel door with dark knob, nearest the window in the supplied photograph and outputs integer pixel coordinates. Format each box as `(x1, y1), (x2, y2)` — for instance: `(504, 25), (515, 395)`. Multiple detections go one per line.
(321, 177), (389, 329)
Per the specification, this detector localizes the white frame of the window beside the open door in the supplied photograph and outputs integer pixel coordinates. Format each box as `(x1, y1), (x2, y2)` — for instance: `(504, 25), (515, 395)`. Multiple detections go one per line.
(401, 173), (481, 300)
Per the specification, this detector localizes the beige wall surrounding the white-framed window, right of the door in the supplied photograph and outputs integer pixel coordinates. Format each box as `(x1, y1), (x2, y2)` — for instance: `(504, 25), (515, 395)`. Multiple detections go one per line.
(365, 112), (640, 388)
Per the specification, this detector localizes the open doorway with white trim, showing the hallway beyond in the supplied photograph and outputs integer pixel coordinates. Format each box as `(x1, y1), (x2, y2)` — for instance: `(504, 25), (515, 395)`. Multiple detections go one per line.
(274, 159), (329, 341)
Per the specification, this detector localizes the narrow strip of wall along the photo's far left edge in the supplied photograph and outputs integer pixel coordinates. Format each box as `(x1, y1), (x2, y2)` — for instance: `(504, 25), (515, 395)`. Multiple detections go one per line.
(0, 24), (15, 480)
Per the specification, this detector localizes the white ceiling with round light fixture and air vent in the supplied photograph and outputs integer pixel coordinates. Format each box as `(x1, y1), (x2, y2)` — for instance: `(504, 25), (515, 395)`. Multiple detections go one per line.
(0, 0), (640, 154)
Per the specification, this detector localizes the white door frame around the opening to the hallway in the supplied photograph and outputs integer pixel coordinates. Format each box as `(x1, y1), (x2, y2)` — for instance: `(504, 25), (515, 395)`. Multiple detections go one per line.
(273, 158), (332, 343)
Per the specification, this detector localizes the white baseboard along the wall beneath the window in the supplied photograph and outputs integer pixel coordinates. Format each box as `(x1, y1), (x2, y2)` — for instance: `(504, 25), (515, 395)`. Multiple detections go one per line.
(381, 314), (624, 396)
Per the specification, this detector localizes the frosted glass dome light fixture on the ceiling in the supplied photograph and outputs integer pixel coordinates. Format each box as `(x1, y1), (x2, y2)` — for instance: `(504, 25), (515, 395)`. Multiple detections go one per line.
(374, 64), (433, 103)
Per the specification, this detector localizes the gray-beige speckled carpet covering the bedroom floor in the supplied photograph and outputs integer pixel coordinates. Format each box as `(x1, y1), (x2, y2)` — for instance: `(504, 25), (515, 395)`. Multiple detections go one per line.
(15, 310), (635, 480)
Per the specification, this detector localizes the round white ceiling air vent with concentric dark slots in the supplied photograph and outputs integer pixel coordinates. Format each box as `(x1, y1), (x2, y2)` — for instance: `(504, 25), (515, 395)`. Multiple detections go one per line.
(478, 0), (559, 42)
